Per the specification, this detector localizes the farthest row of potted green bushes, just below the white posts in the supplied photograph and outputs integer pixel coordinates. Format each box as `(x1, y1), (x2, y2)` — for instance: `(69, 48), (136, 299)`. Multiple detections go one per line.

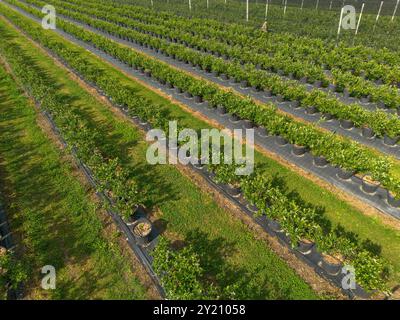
(63, 0), (400, 84)
